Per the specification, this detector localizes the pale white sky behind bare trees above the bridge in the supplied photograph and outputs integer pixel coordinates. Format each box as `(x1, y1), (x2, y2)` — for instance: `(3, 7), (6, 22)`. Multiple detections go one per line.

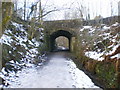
(15, 0), (120, 20)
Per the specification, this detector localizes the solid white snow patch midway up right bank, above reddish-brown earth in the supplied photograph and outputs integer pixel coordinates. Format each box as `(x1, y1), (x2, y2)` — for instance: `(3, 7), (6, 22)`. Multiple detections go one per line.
(85, 51), (104, 61)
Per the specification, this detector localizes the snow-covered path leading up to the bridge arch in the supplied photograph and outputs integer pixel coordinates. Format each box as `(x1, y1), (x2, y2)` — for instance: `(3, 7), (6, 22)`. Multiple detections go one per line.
(10, 53), (99, 88)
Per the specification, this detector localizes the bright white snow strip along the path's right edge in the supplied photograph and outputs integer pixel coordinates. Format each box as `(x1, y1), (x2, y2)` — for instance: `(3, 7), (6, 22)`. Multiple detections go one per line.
(68, 60), (98, 88)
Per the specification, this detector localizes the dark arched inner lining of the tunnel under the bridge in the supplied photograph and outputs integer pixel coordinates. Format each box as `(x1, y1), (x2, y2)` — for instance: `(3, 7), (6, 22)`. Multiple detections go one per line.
(50, 30), (72, 51)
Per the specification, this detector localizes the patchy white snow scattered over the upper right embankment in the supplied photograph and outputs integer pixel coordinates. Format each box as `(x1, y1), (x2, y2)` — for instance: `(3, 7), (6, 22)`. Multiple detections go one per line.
(80, 22), (120, 61)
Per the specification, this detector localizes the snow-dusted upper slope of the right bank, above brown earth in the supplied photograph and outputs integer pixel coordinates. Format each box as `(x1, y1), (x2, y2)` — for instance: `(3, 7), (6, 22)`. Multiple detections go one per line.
(80, 22), (120, 61)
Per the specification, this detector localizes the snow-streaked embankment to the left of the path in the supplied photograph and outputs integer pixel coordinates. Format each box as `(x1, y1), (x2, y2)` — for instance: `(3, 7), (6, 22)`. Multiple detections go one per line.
(0, 21), (43, 87)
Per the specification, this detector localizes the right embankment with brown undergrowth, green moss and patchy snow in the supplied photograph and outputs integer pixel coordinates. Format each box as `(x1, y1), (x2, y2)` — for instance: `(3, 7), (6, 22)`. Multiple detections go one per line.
(71, 20), (120, 88)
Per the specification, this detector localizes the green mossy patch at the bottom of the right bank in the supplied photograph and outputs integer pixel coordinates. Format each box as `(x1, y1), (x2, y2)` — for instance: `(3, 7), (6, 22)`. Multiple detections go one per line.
(96, 62), (117, 88)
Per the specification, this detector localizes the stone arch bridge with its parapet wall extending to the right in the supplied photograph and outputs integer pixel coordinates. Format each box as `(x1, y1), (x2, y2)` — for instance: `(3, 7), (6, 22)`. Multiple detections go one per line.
(43, 16), (120, 51)
